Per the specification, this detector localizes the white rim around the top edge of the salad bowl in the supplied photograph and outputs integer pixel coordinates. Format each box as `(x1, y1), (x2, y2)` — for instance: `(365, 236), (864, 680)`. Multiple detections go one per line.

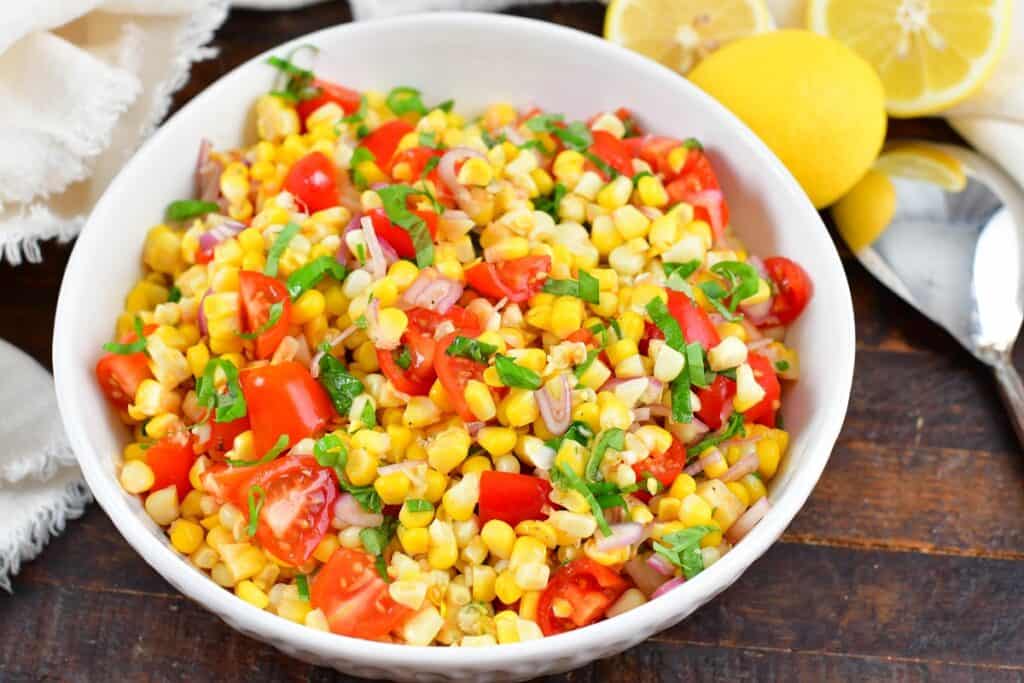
(53, 12), (855, 673)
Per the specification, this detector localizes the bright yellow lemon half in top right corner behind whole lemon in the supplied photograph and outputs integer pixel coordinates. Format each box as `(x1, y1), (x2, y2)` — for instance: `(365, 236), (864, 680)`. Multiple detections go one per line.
(807, 0), (1013, 117)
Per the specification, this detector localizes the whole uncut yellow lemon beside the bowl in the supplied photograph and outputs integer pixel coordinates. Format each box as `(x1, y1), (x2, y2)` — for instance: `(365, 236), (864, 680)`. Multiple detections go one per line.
(690, 30), (886, 208)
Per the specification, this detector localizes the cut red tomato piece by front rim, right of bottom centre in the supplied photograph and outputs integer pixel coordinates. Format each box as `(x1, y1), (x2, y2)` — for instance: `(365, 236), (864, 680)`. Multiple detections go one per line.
(537, 557), (630, 636)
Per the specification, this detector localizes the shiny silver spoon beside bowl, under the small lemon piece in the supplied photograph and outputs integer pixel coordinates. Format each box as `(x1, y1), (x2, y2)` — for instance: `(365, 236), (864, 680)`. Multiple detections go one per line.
(856, 144), (1024, 443)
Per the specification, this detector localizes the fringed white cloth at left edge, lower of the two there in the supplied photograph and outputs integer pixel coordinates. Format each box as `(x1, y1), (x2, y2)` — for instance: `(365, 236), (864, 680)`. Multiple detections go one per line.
(0, 340), (91, 591)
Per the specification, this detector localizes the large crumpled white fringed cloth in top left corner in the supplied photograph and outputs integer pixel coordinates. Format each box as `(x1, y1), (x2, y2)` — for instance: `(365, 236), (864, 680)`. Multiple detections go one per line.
(0, 0), (227, 264)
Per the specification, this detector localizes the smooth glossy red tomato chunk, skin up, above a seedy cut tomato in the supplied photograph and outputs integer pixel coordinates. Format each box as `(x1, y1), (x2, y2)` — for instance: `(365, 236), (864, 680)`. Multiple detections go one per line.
(239, 361), (335, 458)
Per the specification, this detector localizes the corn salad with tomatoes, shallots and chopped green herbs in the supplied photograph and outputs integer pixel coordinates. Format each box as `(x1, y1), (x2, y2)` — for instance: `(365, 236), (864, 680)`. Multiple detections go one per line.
(96, 53), (811, 646)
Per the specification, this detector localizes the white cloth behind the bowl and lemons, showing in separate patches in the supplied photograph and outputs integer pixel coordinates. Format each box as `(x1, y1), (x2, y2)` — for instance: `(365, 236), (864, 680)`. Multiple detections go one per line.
(349, 0), (1024, 192)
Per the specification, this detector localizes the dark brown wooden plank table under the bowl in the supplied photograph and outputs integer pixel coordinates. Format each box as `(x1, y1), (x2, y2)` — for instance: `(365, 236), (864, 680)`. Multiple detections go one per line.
(0, 2), (1024, 683)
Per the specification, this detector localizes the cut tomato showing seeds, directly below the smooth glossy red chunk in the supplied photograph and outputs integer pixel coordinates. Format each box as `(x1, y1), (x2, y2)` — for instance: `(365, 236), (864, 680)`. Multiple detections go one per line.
(248, 456), (338, 566)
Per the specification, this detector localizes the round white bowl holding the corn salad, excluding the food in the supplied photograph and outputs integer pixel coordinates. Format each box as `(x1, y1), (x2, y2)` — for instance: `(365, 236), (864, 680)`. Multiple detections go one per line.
(53, 13), (854, 681)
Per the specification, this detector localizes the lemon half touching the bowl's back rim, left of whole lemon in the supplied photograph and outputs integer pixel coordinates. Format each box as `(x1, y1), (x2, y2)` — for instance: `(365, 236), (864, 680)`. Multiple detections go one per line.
(604, 0), (775, 74)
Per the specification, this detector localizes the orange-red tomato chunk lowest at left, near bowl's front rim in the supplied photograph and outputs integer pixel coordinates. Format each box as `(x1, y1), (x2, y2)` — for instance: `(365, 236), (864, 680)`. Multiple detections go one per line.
(309, 548), (414, 640)
